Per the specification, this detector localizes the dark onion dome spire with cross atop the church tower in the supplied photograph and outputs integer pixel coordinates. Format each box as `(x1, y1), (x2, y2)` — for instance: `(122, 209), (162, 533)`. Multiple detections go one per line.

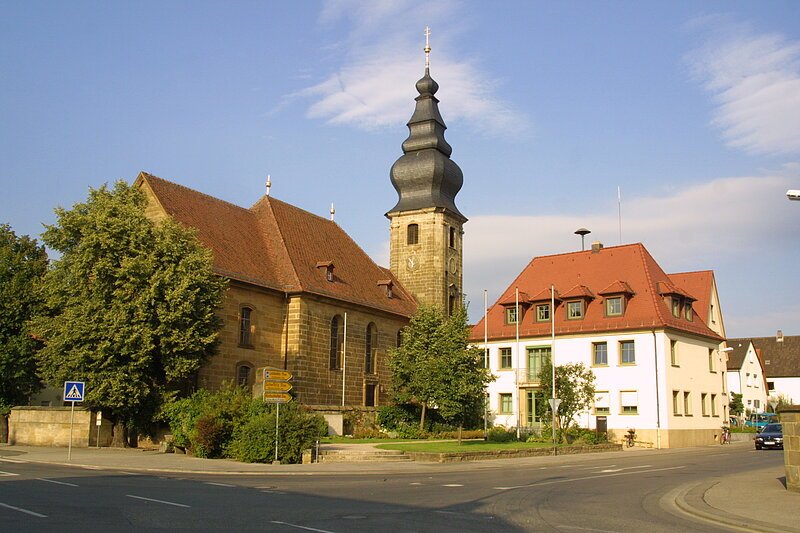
(387, 28), (467, 222)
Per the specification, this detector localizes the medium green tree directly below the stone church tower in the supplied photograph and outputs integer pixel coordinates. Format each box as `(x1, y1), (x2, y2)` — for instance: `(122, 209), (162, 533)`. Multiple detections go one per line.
(389, 306), (493, 431)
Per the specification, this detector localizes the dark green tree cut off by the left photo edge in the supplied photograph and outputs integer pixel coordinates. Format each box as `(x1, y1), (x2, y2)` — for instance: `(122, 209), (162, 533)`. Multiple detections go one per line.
(0, 224), (47, 442)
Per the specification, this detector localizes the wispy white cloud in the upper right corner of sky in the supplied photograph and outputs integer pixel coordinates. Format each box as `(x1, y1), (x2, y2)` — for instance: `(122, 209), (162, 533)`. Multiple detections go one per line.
(688, 17), (800, 154)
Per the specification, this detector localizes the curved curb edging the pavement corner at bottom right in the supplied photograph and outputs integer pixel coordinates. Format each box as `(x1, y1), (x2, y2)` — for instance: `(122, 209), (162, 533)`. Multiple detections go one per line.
(669, 479), (800, 533)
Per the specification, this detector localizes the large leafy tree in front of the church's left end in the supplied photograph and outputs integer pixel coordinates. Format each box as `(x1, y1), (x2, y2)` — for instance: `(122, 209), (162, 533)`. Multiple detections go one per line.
(33, 181), (226, 446)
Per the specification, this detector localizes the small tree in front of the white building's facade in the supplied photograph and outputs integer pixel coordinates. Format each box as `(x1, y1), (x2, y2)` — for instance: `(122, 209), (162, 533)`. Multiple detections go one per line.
(537, 363), (594, 430)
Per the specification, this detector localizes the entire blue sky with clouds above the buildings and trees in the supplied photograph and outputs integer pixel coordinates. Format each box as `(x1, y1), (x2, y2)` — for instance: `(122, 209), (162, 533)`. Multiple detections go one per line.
(0, 0), (800, 337)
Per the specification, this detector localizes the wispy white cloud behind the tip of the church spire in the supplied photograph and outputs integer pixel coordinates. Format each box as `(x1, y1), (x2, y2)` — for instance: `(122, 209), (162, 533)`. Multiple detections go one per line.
(292, 0), (527, 134)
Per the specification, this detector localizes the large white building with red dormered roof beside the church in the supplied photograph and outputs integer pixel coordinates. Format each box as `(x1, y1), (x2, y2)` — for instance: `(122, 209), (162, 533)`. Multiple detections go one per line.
(471, 244), (728, 447)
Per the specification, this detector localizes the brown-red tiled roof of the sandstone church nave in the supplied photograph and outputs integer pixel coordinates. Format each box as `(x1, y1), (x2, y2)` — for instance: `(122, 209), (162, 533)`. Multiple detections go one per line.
(137, 172), (417, 316)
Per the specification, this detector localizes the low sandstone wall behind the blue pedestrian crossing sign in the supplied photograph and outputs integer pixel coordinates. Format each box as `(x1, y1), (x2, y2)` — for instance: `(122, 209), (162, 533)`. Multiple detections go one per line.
(8, 407), (111, 448)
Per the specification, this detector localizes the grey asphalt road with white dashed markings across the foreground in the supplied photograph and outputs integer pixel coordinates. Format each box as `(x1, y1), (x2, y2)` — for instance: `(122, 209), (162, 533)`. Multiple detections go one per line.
(0, 446), (782, 533)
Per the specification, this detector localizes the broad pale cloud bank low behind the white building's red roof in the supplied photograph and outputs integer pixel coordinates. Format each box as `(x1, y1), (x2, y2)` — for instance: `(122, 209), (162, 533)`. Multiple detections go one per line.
(456, 172), (800, 318)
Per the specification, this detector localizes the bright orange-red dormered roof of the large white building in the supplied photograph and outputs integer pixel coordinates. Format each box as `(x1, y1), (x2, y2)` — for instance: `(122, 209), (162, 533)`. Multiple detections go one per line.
(471, 243), (723, 342)
